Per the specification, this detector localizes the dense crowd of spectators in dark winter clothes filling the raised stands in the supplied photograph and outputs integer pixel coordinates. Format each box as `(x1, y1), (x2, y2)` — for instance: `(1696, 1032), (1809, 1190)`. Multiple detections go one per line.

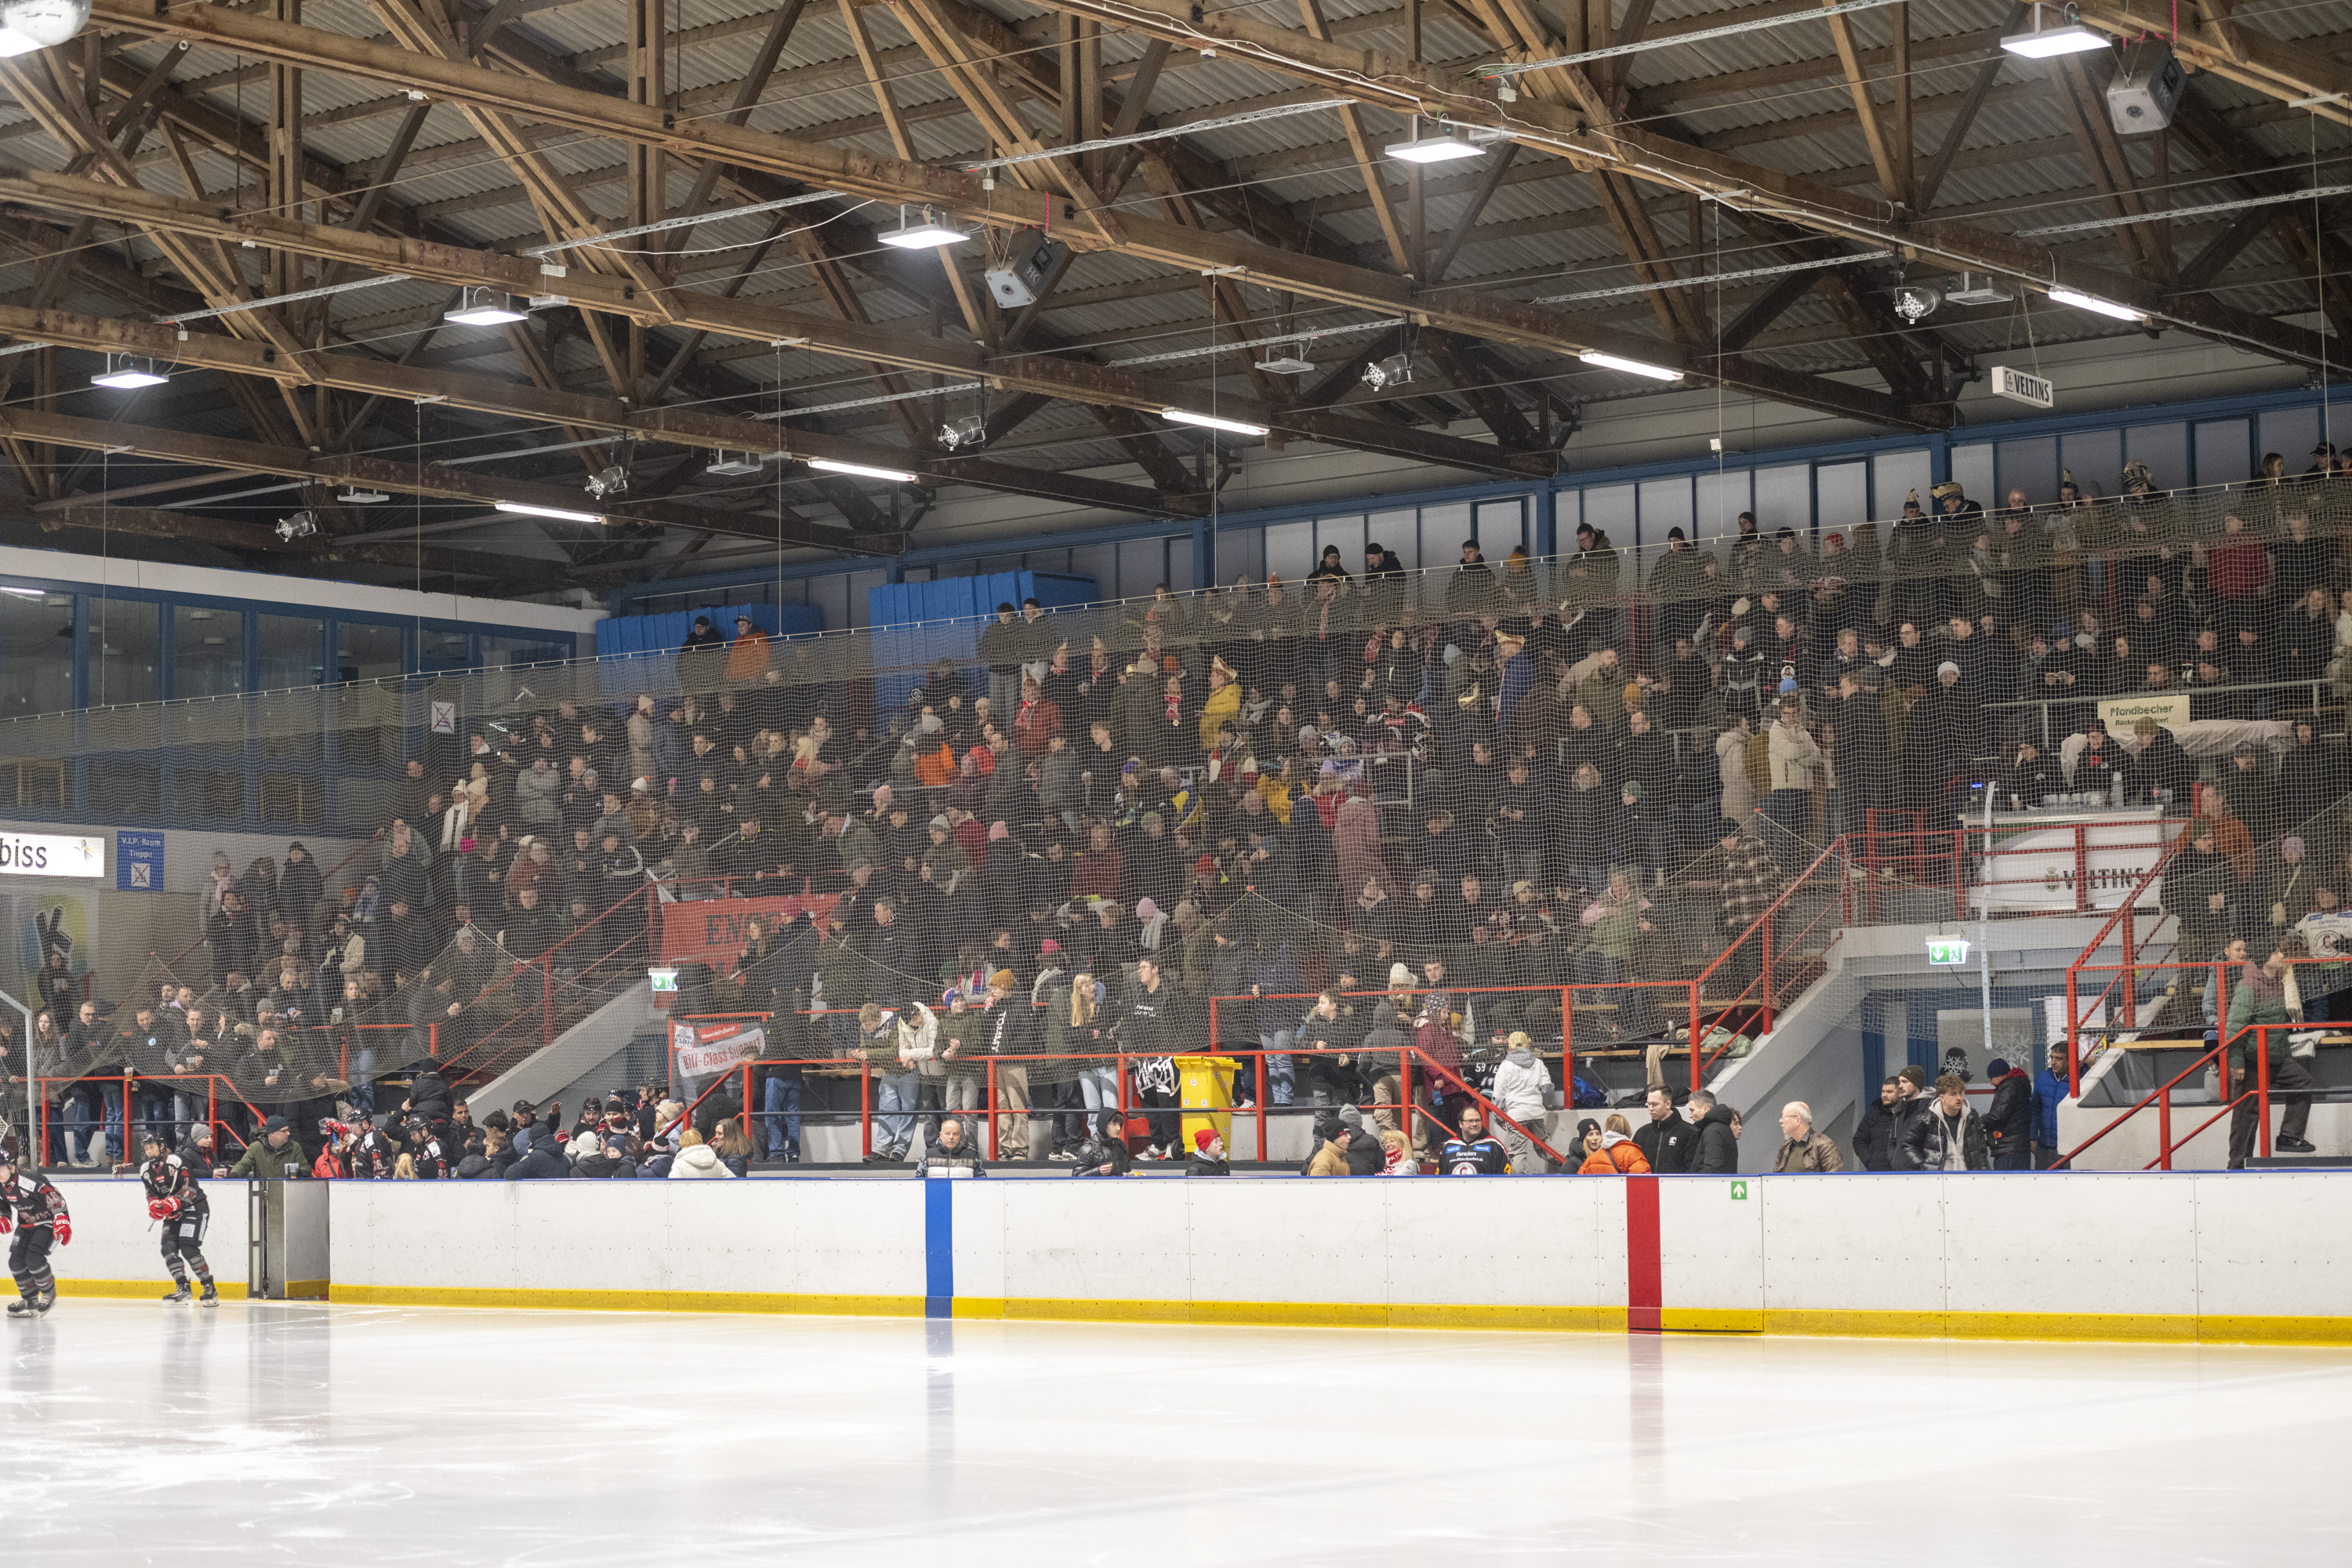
(9, 454), (2352, 1171)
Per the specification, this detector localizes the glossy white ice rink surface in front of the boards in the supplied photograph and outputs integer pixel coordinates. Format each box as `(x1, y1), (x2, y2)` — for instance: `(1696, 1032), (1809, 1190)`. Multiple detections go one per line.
(0, 1286), (2352, 1568)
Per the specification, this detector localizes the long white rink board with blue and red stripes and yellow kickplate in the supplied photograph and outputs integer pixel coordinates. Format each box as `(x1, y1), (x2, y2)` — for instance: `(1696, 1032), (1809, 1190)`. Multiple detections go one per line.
(318, 1173), (2352, 1345)
